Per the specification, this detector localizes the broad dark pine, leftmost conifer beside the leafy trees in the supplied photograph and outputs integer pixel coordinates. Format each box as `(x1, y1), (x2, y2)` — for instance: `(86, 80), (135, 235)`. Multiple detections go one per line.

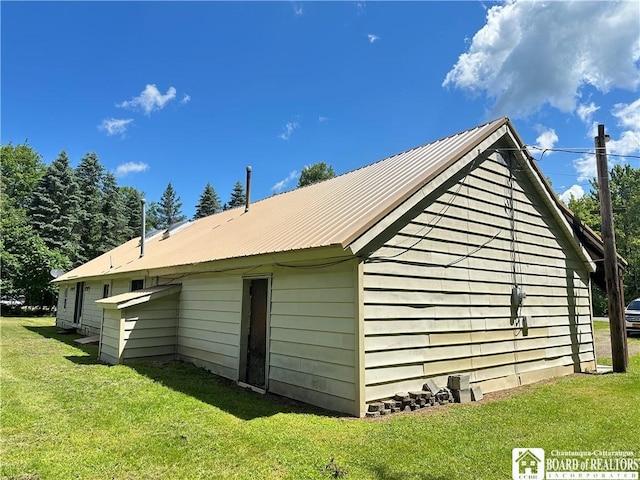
(28, 151), (80, 265)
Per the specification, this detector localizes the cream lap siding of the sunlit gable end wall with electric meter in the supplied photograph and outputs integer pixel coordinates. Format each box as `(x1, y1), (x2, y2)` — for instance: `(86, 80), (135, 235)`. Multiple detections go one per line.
(363, 160), (594, 401)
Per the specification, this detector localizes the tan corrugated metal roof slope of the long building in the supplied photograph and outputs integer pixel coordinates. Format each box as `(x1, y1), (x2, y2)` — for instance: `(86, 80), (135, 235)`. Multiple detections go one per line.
(55, 118), (509, 282)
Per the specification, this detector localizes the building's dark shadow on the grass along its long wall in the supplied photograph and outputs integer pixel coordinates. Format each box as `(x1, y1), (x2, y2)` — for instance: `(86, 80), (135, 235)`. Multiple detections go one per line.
(25, 326), (340, 420)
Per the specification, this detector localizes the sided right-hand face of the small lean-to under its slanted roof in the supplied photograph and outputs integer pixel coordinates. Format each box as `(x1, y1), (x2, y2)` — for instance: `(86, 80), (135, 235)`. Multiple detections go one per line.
(122, 293), (179, 358)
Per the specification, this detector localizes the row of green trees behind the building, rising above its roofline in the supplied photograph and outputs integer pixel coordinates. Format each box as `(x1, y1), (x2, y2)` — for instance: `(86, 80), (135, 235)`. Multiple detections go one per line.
(0, 142), (335, 307)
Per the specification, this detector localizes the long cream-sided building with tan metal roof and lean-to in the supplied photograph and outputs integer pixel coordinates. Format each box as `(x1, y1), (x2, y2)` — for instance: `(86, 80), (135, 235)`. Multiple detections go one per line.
(55, 118), (595, 416)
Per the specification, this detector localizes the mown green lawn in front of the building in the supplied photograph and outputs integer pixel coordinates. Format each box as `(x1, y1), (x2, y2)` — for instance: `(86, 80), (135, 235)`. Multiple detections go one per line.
(0, 318), (640, 480)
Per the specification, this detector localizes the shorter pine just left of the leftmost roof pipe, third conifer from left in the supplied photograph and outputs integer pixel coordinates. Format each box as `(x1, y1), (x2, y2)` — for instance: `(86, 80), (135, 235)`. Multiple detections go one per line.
(100, 173), (129, 252)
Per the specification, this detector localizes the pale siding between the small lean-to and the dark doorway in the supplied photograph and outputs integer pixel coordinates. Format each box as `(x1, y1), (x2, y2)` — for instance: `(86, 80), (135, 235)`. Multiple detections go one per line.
(178, 275), (242, 380)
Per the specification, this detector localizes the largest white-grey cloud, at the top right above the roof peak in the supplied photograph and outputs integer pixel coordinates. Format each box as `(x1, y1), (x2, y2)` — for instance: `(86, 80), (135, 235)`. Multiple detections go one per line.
(443, 0), (640, 116)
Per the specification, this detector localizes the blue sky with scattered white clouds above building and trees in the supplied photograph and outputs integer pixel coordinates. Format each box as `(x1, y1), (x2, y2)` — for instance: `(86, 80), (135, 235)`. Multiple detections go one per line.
(0, 1), (640, 216)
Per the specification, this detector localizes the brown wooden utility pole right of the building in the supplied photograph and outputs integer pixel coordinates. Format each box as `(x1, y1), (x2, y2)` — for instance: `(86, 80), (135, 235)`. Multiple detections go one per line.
(595, 124), (627, 373)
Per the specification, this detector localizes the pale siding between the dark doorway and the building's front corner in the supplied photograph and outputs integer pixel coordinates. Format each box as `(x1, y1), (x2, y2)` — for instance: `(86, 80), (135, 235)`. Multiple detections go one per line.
(269, 262), (356, 413)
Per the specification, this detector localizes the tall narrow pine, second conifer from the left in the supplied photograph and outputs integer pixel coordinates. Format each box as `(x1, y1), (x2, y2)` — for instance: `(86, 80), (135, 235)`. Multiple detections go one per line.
(76, 152), (106, 262)
